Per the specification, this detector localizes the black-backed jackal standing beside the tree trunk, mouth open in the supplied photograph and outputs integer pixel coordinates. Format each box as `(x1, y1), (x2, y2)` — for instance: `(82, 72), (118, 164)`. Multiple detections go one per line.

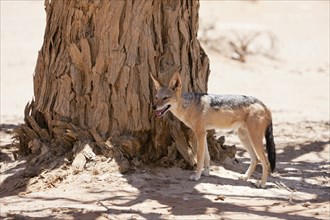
(150, 72), (276, 188)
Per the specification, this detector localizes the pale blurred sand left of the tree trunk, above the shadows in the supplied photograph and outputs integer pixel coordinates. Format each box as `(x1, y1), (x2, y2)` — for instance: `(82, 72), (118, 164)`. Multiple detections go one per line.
(0, 0), (46, 124)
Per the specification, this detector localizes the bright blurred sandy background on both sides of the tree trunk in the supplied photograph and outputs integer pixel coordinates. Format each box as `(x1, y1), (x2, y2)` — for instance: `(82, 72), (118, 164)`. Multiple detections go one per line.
(0, 0), (330, 124)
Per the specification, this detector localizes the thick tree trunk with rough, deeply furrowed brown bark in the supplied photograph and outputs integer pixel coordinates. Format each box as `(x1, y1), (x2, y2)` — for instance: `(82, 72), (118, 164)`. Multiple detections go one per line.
(17, 0), (236, 172)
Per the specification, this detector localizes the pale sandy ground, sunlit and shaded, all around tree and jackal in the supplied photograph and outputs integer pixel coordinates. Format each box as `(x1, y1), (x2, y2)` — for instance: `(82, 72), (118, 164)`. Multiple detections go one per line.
(0, 1), (330, 219)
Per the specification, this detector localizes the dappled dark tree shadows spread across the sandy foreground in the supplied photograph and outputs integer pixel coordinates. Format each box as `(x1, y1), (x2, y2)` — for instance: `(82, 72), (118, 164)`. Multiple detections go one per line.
(0, 124), (330, 220)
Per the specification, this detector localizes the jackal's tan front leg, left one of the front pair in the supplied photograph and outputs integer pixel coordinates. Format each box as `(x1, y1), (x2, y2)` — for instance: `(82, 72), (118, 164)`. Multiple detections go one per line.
(190, 132), (206, 181)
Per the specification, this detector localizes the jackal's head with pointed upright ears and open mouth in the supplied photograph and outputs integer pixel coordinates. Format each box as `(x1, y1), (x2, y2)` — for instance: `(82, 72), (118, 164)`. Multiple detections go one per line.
(150, 72), (182, 117)
